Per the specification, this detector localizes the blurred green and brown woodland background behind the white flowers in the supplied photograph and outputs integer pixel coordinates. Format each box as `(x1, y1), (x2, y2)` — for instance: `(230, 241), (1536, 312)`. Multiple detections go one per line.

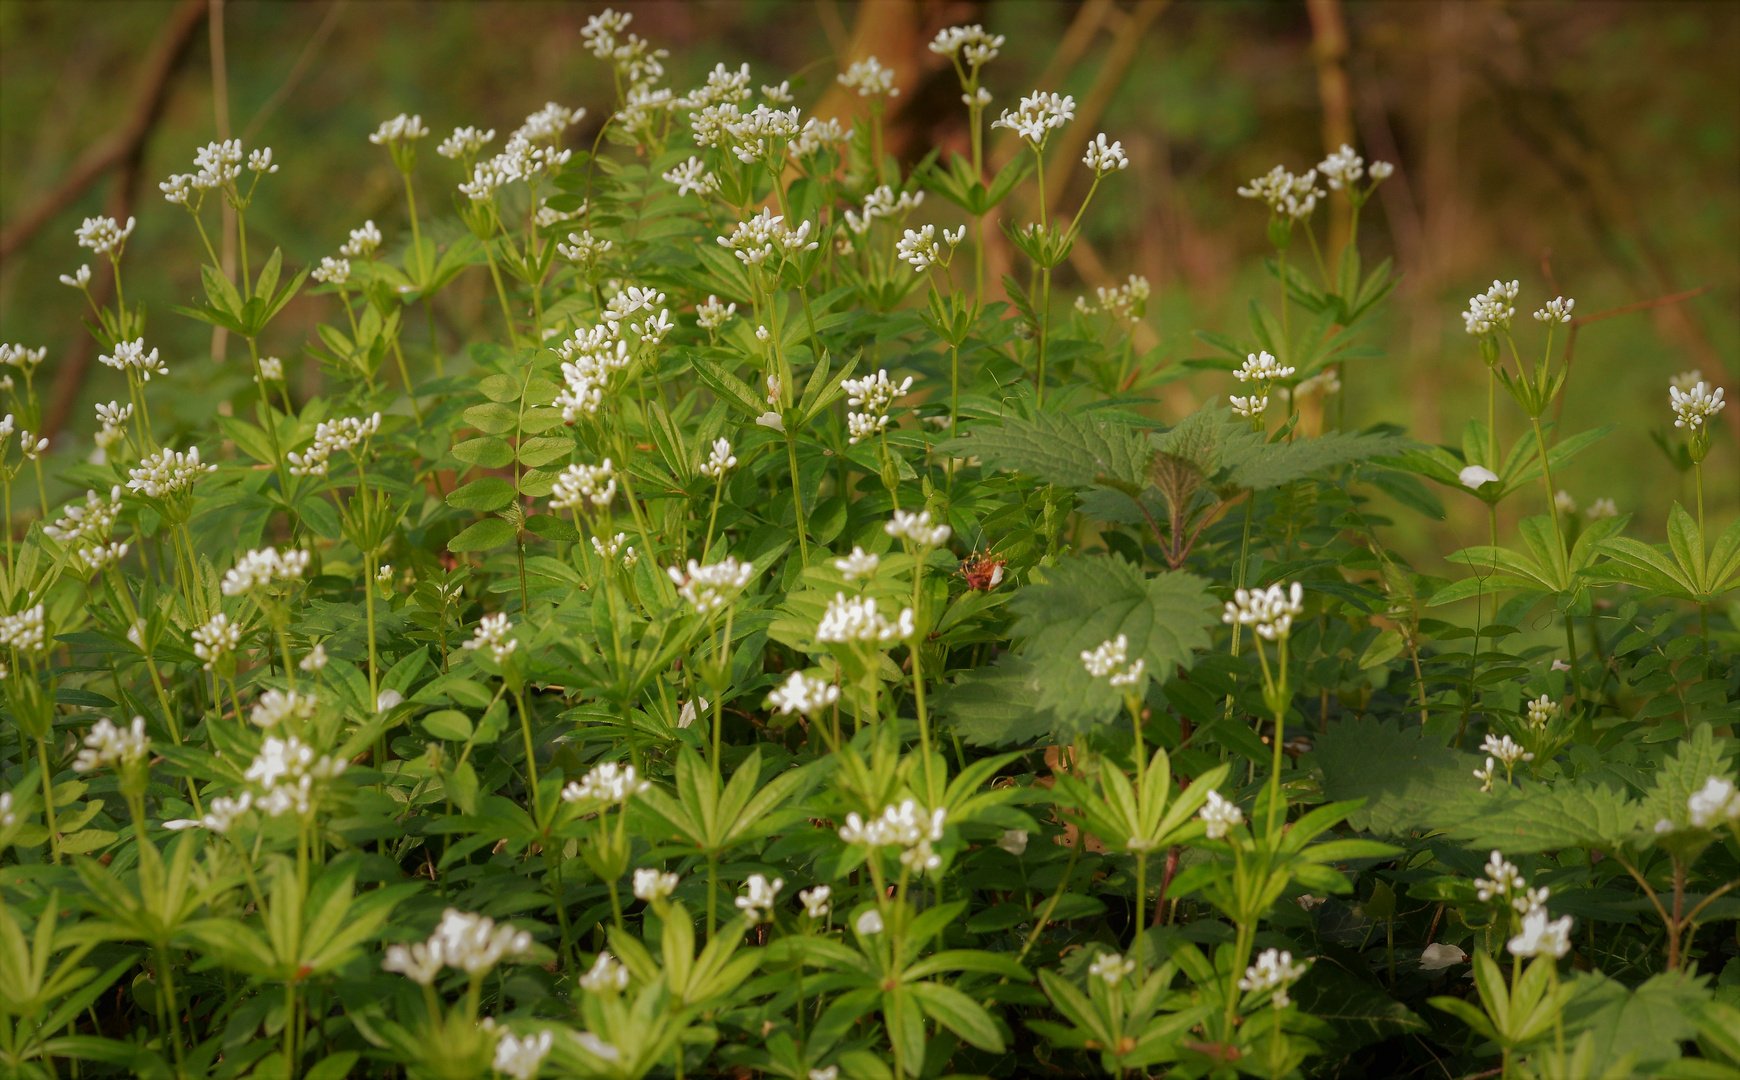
(0, 0), (1740, 572)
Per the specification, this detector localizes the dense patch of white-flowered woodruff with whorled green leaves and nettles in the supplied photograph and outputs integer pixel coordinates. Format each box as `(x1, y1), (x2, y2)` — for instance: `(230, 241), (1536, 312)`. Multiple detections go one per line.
(0, 12), (1740, 1080)
